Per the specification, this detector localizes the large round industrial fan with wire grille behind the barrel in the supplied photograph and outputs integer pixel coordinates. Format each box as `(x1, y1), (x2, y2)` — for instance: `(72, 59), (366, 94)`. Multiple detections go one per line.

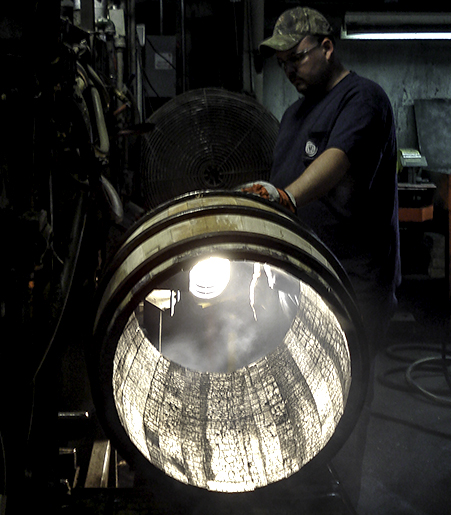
(141, 88), (279, 208)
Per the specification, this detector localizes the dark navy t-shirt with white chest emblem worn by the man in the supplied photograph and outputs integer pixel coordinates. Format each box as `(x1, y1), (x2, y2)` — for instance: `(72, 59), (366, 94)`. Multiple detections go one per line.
(270, 72), (400, 288)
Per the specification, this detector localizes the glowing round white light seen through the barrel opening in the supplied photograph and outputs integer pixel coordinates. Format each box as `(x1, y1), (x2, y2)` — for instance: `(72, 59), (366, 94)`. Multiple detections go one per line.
(189, 257), (230, 299)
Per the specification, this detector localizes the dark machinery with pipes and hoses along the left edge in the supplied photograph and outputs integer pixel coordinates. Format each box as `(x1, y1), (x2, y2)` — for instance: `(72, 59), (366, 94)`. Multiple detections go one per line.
(0, 1), (137, 513)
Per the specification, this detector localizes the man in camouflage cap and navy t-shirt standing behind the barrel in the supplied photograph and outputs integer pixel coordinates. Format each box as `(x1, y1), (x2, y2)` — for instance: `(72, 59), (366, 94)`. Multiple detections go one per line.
(247, 7), (400, 504)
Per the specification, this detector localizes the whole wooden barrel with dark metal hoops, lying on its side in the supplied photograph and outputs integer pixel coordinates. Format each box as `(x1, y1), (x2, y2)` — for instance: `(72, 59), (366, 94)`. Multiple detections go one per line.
(91, 191), (367, 492)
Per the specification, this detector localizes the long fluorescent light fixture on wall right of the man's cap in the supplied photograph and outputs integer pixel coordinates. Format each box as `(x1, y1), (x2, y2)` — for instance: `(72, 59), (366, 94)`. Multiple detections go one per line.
(341, 12), (451, 40)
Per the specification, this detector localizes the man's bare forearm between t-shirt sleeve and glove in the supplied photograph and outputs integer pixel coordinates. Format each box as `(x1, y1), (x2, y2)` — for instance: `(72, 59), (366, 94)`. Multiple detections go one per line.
(285, 148), (351, 207)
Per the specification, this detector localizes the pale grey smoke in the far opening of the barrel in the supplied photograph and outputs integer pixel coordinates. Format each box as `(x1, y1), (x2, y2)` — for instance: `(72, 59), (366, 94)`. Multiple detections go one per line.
(147, 262), (299, 373)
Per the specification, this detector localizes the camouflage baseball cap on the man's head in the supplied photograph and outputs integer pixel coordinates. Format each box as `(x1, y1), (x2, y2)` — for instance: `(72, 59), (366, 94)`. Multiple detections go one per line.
(259, 7), (333, 52)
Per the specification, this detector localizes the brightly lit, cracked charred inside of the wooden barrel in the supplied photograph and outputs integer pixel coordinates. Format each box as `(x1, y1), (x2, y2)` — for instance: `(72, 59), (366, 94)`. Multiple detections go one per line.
(113, 261), (351, 492)
